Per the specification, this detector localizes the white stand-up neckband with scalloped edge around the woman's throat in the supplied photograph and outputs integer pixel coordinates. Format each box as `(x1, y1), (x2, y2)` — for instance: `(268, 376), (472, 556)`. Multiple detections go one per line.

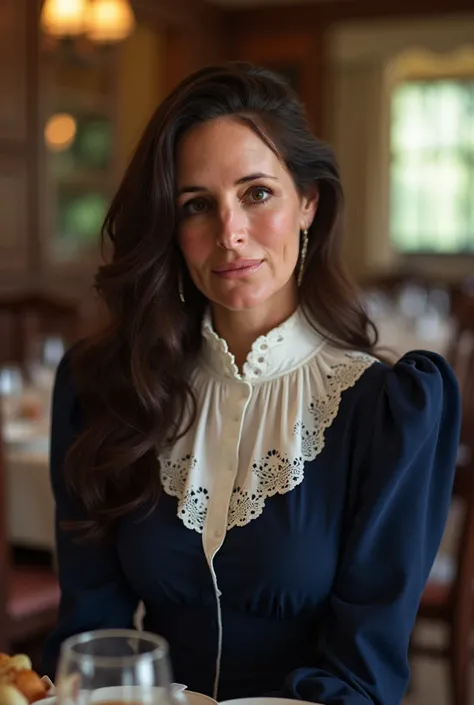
(202, 308), (324, 383)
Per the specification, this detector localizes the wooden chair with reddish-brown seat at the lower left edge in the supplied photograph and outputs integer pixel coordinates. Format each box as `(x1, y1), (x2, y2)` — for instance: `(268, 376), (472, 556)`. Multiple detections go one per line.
(0, 402), (59, 652)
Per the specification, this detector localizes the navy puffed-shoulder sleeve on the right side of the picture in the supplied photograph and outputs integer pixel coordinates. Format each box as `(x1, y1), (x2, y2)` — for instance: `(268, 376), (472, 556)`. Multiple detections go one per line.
(282, 353), (461, 705)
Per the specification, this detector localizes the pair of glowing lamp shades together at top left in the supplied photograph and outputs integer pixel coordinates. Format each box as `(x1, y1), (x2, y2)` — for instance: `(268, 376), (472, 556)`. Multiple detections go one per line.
(41, 0), (135, 43)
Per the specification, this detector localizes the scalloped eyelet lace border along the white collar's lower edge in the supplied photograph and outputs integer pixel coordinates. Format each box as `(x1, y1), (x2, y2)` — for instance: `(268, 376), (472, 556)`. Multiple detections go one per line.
(161, 352), (374, 533)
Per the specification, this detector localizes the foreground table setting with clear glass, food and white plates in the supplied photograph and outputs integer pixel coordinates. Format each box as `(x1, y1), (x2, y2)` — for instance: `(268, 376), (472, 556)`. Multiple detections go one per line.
(0, 629), (322, 705)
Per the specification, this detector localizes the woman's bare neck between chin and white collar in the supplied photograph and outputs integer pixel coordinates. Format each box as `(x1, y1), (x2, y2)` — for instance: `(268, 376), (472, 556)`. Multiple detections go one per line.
(212, 284), (298, 371)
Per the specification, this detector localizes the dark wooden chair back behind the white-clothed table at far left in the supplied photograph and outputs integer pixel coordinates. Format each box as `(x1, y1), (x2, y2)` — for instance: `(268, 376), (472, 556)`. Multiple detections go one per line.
(0, 292), (81, 369)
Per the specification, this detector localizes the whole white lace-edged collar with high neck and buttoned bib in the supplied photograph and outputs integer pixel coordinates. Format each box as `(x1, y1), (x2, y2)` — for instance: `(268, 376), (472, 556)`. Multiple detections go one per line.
(160, 311), (375, 540)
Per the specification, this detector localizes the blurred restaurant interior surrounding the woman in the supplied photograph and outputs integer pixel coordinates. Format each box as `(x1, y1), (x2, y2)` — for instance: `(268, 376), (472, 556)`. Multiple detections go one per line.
(0, 0), (474, 705)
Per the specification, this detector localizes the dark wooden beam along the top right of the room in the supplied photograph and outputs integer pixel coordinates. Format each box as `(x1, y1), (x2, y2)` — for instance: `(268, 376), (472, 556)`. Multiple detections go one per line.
(225, 0), (474, 34)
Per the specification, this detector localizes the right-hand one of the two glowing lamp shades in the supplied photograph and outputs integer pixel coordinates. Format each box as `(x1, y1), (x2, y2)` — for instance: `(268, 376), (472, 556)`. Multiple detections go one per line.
(85, 0), (135, 43)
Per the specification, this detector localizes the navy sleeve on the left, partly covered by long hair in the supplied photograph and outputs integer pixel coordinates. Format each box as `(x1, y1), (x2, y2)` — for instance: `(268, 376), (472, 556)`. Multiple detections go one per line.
(43, 355), (138, 678)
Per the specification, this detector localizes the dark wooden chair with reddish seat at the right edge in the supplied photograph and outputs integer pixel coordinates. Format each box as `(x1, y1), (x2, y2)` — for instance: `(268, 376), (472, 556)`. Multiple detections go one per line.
(410, 295), (474, 705)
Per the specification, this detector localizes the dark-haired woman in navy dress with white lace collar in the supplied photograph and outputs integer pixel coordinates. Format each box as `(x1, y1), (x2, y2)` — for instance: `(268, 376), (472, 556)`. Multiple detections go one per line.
(46, 64), (459, 705)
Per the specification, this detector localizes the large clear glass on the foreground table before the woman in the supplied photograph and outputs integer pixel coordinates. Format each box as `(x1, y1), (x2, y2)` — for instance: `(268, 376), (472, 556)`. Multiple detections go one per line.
(57, 629), (181, 705)
